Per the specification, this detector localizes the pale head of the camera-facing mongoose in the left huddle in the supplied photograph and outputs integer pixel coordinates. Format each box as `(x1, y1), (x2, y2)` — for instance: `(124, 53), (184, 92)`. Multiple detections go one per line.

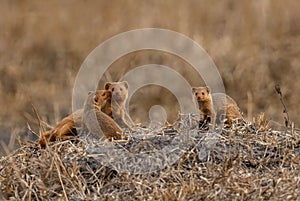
(104, 81), (128, 103)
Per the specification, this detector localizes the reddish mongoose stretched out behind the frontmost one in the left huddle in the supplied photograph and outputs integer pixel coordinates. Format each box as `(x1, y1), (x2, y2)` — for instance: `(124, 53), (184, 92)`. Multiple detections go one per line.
(39, 90), (111, 148)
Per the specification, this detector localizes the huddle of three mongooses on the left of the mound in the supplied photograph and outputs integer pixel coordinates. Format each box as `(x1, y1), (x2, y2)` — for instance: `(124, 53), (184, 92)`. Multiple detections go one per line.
(39, 81), (131, 148)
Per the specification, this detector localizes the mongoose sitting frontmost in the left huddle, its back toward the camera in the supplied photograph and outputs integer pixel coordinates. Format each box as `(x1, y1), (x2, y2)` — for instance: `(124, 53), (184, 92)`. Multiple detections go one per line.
(83, 90), (122, 140)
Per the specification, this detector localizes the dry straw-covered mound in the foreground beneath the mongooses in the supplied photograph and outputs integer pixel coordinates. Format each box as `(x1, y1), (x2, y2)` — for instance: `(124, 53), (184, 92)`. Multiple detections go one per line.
(0, 115), (300, 200)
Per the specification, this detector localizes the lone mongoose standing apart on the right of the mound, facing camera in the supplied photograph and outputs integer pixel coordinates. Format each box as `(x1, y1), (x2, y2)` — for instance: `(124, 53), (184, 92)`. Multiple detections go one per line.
(192, 86), (242, 128)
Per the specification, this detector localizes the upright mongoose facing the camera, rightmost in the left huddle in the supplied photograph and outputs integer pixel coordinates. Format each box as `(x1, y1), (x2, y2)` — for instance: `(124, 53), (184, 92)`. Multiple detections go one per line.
(102, 81), (133, 130)
